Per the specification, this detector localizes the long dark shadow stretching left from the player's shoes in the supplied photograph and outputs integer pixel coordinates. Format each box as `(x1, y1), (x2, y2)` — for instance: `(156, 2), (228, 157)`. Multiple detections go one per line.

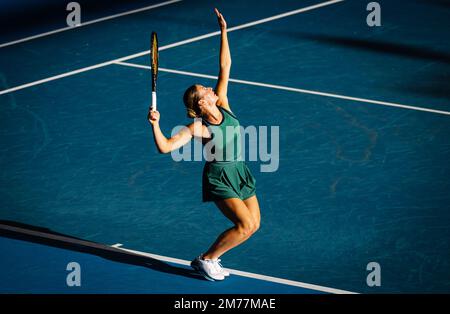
(0, 220), (206, 280)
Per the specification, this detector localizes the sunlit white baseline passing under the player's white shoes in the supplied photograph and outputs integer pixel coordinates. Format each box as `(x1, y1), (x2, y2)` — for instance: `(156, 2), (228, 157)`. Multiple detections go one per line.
(119, 248), (357, 294)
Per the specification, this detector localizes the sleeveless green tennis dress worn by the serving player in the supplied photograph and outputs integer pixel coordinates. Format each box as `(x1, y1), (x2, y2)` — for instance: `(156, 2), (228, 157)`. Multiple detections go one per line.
(202, 106), (256, 202)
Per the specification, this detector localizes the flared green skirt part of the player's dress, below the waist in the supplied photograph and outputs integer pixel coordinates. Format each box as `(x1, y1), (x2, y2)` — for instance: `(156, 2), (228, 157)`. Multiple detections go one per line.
(202, 161), (256, 202)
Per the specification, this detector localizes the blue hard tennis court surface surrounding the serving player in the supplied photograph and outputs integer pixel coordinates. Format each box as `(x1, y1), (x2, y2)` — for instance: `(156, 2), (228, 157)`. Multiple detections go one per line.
(0, 0), (450, 293)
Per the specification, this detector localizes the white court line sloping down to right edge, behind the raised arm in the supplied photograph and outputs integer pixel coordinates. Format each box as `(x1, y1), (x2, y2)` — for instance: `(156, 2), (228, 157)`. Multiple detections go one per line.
(116, 62), (450, 115)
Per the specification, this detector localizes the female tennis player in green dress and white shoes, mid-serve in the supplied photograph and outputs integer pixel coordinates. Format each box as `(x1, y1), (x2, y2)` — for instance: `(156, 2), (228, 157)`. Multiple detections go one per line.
(148, 9), (260, 281)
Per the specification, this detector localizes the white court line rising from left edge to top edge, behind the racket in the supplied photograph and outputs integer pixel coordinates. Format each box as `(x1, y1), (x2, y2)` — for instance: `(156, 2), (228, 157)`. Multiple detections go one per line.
(0, 0), (343, 95)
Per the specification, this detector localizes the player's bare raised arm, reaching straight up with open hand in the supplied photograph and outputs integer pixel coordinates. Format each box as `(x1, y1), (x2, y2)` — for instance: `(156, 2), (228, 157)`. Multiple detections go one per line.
(214, 9), (231, 109)
